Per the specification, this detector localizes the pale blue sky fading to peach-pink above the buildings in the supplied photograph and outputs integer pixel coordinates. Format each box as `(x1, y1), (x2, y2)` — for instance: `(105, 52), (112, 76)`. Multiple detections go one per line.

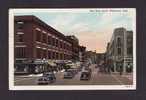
(14, 10), (134, 53)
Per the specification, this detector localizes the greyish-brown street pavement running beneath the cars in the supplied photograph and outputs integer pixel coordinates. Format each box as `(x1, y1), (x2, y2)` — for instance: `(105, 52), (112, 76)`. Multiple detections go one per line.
(14, 64), (132, 86)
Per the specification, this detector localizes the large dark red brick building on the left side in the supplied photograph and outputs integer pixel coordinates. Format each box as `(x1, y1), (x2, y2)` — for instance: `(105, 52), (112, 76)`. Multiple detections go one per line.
(14, 16), (78, 71)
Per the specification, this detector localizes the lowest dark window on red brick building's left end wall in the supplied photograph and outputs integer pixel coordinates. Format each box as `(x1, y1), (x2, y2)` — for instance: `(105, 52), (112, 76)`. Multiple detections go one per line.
(15, 47), (26, 58)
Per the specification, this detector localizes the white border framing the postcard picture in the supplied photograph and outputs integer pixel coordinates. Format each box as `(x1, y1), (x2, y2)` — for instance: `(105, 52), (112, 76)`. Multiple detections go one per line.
(9, 8), (136, 90)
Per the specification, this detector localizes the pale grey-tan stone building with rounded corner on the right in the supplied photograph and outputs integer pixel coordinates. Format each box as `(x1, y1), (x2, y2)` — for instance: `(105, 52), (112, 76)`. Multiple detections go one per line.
(106, 28), (133, 72)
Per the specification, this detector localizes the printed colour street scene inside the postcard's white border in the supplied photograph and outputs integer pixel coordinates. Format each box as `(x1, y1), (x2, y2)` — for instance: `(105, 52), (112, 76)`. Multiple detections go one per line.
(10, 10), (134, 86)
